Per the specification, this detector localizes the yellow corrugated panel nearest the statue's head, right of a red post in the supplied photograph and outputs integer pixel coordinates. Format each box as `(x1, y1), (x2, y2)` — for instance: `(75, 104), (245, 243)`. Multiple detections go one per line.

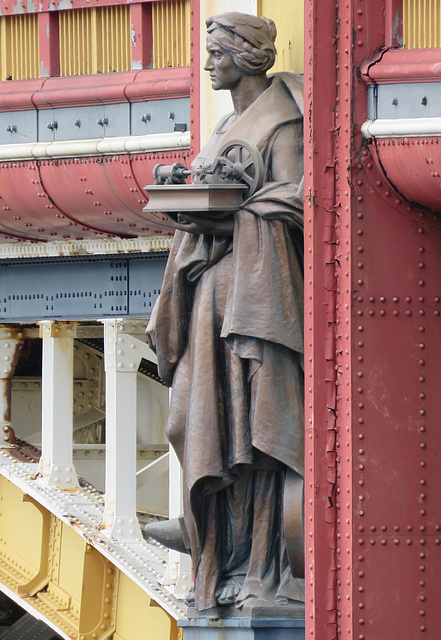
(152, 0), (190, 69)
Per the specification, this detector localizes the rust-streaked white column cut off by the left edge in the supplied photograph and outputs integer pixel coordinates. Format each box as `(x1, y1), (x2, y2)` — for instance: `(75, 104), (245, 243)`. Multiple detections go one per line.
(0, 325), (23, 447)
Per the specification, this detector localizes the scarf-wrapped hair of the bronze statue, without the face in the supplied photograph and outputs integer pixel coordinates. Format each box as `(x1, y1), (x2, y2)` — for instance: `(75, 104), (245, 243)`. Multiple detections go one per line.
(206, 12), (277, 76)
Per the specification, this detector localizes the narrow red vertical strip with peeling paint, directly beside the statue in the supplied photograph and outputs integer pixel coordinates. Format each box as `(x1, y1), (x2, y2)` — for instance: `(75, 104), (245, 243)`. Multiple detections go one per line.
(304, 0), (337, 640)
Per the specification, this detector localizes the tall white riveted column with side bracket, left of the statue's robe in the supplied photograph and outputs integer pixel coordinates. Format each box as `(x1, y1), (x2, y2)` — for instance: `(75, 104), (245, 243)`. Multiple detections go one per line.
(102, 318), (156, 541)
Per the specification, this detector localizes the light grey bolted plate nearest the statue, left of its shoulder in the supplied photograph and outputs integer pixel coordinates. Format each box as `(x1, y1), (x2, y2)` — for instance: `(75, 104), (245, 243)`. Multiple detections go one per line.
(130, 98), (190, 136)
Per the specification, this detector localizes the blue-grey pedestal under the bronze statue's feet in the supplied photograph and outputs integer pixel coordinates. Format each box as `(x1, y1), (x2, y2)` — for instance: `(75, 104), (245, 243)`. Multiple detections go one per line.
(178, 616), (305, 640)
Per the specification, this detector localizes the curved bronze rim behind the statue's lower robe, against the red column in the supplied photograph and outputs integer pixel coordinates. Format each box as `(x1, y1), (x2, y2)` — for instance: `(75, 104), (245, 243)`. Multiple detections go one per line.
(283, 469), (305, 578)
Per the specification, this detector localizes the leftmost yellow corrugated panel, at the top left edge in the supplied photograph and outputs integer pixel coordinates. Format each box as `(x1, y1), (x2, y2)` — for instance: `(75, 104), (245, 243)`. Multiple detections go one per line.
(0, 14), (40, 80)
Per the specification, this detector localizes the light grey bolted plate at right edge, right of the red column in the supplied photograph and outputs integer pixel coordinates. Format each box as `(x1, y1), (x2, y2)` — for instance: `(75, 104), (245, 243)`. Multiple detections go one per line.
(369, 82), (441, 119)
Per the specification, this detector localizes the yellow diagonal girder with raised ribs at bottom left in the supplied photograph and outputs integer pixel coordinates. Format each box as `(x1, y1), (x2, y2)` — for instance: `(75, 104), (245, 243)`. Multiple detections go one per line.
(0, 476), (182, 640)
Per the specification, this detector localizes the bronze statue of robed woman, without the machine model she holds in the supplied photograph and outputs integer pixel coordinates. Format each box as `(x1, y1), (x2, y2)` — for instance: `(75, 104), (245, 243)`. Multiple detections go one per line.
(147, 13), (304, 611)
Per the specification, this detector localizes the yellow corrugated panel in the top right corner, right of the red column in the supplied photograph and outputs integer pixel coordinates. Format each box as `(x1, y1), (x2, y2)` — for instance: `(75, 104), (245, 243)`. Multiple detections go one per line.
(403, 0), (441, 49)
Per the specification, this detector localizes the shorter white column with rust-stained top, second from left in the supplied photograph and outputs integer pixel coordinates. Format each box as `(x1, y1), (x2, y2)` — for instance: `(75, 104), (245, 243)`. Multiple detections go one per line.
(39, 320), (78, 489)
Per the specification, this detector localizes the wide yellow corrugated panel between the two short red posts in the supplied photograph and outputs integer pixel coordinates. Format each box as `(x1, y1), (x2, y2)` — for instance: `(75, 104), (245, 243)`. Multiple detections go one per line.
(60, 5), (131, 76)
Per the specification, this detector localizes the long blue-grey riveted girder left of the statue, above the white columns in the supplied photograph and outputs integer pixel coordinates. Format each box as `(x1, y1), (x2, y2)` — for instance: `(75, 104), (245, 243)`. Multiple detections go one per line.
(0, 254), (167, 322)
